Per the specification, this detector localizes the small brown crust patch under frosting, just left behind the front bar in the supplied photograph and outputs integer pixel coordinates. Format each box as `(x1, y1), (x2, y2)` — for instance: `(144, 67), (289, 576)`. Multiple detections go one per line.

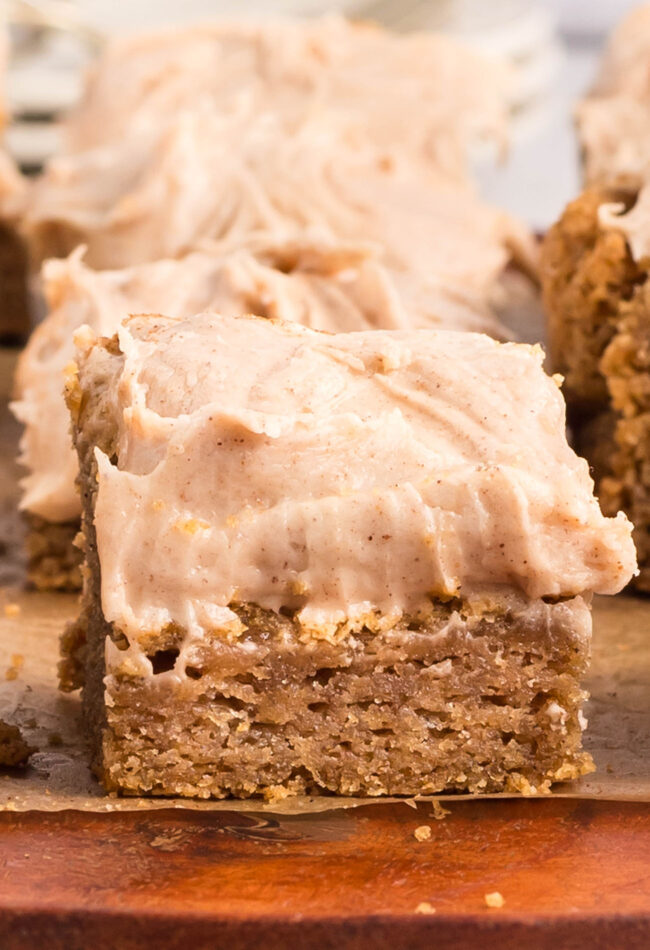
(25, 514), (83, 591)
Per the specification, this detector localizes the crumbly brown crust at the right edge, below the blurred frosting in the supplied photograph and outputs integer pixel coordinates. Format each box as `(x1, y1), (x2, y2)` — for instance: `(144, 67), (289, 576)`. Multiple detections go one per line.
(541, 187), (650, 591)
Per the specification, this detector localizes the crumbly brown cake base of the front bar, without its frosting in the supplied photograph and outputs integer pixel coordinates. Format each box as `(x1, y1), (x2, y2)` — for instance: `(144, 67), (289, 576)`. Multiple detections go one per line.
(62, 342), (592, 798)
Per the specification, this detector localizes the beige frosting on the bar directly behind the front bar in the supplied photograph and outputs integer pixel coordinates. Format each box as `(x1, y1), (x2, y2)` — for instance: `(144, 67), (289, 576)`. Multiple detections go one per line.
(12, 234), (507, 521)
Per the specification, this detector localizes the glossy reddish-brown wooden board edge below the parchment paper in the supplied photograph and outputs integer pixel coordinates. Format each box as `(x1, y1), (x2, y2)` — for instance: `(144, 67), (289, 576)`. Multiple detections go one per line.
(0, 799), (650, 950)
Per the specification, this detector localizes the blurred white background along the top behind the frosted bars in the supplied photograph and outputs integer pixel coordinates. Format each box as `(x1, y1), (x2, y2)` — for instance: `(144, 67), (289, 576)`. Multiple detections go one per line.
(0, 0), (637, 230)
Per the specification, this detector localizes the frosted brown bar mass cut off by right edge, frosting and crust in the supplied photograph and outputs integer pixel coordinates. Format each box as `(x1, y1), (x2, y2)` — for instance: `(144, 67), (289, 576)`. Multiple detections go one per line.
(541, 4), (650, 591)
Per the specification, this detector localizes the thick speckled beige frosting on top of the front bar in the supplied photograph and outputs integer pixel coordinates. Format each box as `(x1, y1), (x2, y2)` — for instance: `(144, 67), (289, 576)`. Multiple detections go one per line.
(80, 314), (635, 671)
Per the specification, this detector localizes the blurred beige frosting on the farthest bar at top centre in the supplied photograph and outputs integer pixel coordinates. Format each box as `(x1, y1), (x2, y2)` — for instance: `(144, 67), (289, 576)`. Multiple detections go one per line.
(65, 16), (510, 178)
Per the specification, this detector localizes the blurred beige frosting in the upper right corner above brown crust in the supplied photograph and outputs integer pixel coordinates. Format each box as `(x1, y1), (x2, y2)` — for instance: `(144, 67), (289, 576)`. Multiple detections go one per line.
(576, 4), (650, 184)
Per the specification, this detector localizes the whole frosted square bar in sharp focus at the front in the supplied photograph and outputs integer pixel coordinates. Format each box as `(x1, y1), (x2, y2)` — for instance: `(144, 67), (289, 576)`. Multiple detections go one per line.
(64, 314), (635, 797)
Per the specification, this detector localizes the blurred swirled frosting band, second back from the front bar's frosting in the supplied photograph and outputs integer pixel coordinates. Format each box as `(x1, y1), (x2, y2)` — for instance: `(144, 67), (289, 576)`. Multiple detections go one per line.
(23, 101), (527, 286)
